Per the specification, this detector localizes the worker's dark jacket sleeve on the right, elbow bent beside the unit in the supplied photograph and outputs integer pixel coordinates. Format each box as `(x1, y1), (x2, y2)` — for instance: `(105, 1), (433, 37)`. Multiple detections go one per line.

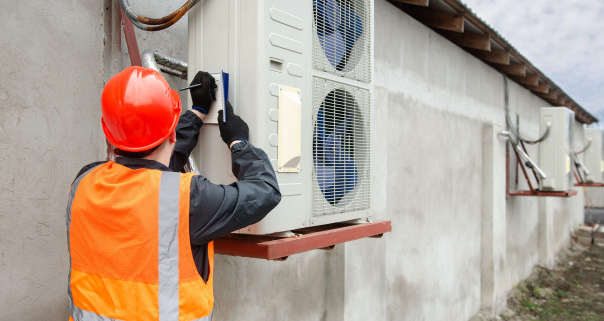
(189, 142), (281, 245)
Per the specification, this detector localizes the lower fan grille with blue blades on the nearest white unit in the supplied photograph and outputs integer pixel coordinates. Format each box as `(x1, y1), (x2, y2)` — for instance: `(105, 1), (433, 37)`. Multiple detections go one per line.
(313, 77), (371, 216)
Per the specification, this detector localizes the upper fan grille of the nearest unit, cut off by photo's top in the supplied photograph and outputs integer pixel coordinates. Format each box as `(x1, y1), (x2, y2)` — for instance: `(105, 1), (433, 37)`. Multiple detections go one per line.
(313, 0), (372, 83)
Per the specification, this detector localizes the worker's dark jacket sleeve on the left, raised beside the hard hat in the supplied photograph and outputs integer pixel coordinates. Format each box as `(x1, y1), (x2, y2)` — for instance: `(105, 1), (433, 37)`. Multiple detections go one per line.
(169, 110), (203, 172)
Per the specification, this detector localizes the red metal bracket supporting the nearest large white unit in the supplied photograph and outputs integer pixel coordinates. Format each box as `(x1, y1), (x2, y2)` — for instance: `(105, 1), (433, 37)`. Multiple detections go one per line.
(214, 221), (392, 261)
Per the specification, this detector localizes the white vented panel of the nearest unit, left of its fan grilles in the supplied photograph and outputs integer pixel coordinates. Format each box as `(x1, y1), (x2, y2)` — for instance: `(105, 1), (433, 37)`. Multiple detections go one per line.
(239, 0), (312, 234)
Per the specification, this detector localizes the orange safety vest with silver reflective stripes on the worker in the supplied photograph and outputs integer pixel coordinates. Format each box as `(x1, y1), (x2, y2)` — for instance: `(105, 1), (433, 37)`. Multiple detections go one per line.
(67, 162), (214, 321)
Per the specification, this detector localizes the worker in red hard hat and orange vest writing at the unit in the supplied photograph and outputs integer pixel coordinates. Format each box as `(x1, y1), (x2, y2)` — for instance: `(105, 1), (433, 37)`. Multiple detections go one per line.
(67, 67), (281, 321)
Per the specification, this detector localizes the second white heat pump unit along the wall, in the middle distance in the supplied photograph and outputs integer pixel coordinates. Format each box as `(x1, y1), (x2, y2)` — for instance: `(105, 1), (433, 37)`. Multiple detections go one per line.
(539, 107), (575, 191)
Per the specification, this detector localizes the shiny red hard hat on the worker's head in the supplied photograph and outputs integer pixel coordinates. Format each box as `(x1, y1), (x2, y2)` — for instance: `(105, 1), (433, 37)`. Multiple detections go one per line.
(101, 66), (181, 152)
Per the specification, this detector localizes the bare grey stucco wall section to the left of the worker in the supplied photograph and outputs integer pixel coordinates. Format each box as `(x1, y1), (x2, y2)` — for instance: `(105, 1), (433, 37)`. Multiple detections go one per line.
(0, 1), (104, 320)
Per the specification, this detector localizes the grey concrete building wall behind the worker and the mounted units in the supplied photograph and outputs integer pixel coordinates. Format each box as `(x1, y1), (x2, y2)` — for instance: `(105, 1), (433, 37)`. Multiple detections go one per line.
(0, 0), (584, 320)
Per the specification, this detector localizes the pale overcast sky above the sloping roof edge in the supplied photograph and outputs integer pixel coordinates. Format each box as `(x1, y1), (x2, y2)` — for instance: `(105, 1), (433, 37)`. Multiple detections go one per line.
(462, 0), (604, 127)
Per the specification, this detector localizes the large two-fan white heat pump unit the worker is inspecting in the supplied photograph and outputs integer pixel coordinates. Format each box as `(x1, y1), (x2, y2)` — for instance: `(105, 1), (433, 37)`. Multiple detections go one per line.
(189, 0), (373, 234)
